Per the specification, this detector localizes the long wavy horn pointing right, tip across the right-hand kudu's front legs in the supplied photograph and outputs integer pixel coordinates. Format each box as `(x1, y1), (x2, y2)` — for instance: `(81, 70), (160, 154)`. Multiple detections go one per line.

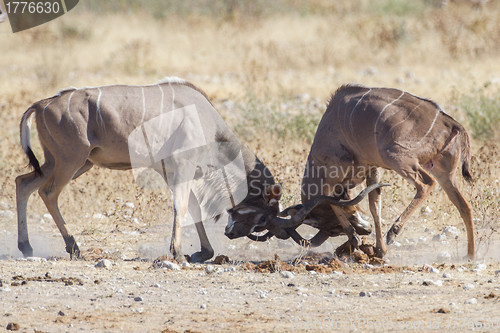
(270, 183), (391, 231)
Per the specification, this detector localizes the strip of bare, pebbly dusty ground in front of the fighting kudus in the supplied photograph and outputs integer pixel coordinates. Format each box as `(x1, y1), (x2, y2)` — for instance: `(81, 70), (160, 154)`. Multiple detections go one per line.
(0, 253), (500, 332)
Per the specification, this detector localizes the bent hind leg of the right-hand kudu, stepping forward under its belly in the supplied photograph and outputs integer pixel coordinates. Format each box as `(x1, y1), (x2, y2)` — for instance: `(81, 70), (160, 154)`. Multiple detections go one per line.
(387, 164), (436, 244)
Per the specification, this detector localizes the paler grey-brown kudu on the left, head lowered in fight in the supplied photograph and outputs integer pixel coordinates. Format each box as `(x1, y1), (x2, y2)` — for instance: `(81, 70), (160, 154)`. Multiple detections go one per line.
(16, 78), (280, 261)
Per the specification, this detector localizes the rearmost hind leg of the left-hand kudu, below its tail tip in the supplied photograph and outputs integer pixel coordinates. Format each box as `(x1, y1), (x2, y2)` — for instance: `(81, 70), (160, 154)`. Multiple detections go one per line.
(16, 163), (52, 257)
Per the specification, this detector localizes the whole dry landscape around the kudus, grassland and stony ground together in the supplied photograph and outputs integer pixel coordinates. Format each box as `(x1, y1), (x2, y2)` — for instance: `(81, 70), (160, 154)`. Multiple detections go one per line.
(0, 0), (500, 332)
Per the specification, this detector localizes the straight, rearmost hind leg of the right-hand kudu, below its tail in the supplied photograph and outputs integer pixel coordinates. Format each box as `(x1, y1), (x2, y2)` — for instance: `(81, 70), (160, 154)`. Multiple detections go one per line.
(432, 154), (476, 259)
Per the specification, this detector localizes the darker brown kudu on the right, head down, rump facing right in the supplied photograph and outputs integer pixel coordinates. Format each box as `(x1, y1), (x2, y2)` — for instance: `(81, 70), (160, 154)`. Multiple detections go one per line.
(282, 85), (475, 258)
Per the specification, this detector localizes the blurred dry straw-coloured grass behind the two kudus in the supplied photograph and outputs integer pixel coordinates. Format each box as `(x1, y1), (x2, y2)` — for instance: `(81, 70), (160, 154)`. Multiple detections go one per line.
(0, 0), (500, 260)
